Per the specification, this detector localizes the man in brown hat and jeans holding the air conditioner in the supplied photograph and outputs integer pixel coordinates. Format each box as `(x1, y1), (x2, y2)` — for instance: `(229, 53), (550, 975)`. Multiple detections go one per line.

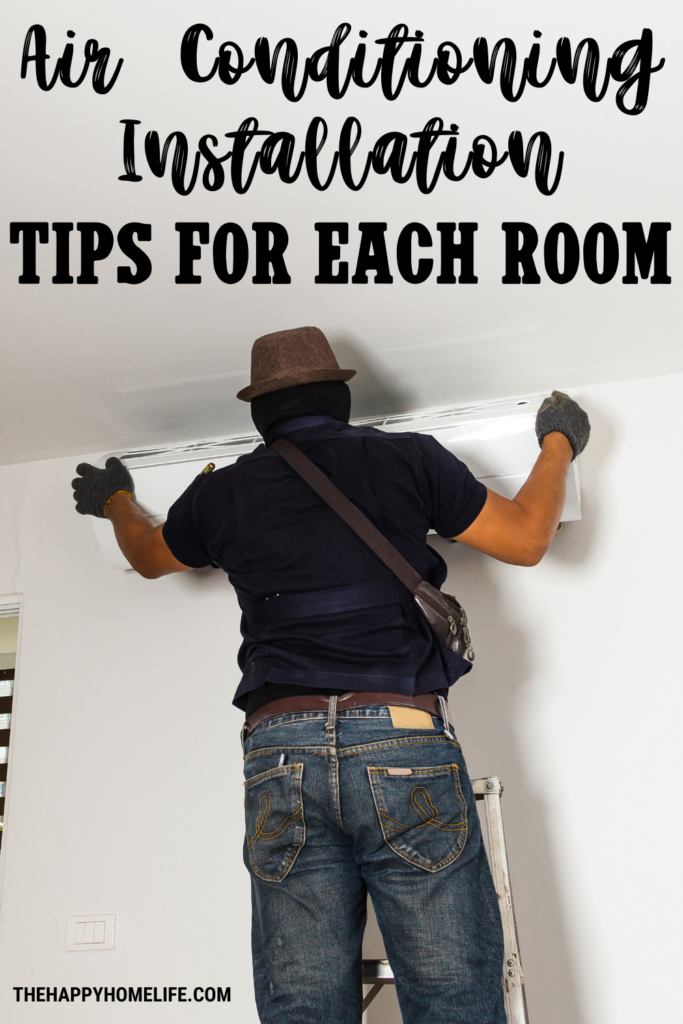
(74, 328), (590, 1024)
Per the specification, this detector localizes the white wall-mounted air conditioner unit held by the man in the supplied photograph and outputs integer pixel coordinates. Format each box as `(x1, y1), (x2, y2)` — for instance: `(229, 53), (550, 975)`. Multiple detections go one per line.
(93, 395), (581, 569)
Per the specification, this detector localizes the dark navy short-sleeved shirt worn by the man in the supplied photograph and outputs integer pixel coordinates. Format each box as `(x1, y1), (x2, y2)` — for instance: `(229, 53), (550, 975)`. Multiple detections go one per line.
(163, 417), (486, 709)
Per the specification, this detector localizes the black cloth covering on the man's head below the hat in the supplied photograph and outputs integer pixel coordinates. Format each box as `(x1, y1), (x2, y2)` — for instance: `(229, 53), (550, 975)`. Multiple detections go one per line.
(251, 381), (351, 445)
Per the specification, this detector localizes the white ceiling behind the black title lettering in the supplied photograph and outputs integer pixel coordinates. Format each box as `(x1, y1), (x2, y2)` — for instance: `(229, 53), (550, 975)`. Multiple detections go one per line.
(0, 0), (683, 463)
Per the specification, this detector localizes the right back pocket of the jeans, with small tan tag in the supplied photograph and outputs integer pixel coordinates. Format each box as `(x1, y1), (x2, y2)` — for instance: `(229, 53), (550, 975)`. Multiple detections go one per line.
(368, 764), (467, 871)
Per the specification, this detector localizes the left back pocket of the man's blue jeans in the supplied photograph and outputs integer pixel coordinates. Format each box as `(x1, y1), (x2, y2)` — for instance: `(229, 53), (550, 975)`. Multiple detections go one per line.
(245, 764), (306, 882)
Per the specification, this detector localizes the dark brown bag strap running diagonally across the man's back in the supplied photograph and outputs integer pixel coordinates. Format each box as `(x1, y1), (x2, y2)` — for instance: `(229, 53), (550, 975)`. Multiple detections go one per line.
(270, 438), (422, 594)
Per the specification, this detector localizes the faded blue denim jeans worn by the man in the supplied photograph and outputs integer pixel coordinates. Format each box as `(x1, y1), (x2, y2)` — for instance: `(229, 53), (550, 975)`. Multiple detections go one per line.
(245, 696), (506, 1024)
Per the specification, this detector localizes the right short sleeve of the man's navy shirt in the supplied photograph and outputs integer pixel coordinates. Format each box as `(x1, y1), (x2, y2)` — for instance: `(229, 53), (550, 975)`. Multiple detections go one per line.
(414, 434), (487, 537)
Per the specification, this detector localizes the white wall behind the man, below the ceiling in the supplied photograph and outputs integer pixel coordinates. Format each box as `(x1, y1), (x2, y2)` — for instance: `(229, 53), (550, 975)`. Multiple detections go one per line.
(0, 375), (683, 1024)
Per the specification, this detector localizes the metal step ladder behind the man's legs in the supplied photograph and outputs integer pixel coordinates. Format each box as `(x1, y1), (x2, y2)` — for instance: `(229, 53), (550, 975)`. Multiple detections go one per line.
(362, 775), (528, 1024)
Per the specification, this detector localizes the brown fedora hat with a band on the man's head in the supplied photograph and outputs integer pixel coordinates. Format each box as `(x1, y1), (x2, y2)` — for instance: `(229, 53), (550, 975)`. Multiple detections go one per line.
(238, 327), (355, 401)
